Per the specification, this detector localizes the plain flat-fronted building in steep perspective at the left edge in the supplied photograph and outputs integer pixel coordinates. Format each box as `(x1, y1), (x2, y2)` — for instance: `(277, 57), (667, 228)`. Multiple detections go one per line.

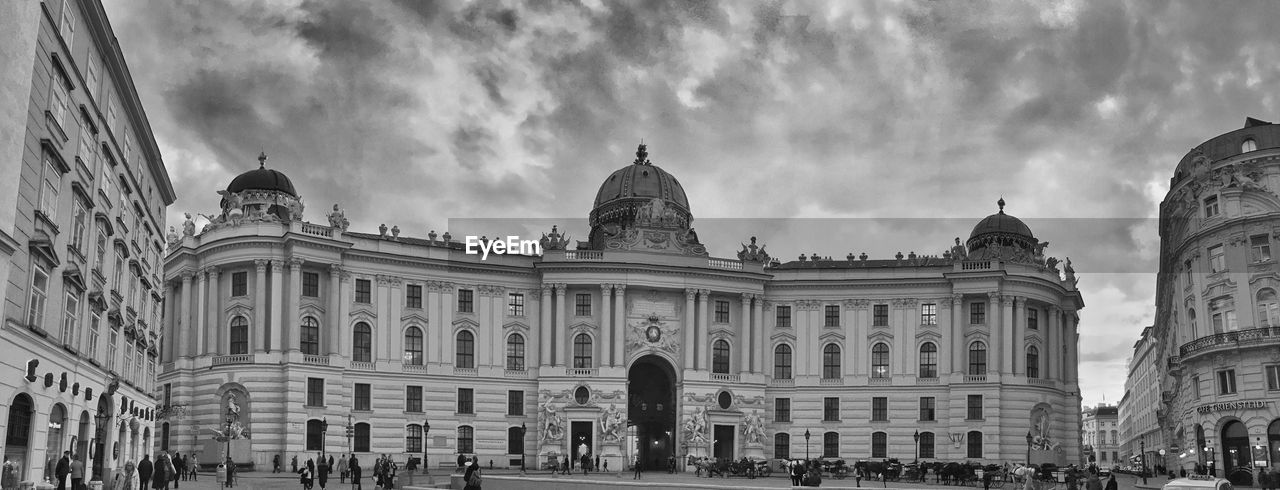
(0, 0), (175, 481)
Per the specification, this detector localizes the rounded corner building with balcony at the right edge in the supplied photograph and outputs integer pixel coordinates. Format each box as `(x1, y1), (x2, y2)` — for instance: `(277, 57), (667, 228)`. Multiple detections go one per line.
(1155, 118), (1280, 482)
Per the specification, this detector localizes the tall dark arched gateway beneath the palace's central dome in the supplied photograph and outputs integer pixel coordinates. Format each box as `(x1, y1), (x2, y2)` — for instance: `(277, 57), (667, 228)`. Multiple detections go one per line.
(627, 356), (676, 470)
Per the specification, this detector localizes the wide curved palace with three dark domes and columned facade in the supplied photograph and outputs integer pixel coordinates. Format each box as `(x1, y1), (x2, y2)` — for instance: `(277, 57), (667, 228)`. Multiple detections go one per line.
(159, 145), (1083, 470)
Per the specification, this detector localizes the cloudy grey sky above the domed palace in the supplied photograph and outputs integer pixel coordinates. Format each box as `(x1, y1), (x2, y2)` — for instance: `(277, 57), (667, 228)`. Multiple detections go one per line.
(104, 0), (1280, 404)
